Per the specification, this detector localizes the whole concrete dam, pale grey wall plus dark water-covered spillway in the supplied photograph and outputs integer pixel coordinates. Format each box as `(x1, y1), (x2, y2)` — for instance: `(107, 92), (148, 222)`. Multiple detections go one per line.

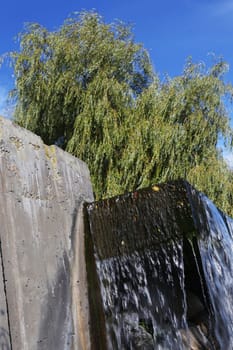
(0, 118), (233, 350)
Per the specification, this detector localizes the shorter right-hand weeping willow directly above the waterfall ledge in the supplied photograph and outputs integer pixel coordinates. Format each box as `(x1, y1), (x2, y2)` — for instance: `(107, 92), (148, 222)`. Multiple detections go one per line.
(121, 59), (233, 215)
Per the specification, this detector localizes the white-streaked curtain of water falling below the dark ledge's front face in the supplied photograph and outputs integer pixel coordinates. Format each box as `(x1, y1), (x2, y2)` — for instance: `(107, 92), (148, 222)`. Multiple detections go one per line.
(97, 242), (185, 350)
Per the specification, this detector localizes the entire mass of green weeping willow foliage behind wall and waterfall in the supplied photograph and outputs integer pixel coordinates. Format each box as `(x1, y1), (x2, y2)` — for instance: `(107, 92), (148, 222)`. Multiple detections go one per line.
(8, 12), (233, 214)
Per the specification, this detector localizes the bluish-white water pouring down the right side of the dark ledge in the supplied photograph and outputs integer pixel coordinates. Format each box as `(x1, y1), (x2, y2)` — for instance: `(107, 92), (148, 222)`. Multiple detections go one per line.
(198, 196), (233, 350)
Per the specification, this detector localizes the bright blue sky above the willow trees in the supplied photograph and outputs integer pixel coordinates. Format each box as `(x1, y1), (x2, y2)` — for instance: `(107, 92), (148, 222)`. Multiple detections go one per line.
(0, 0), (233, 163)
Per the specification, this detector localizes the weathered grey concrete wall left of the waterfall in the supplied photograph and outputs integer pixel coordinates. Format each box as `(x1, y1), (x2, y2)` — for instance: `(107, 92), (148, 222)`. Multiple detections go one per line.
(0, 118), (93, 350)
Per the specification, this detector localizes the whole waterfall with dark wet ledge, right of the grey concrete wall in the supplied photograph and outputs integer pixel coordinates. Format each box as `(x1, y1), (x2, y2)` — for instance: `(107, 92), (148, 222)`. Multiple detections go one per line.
(86, 181), (233, 350)
